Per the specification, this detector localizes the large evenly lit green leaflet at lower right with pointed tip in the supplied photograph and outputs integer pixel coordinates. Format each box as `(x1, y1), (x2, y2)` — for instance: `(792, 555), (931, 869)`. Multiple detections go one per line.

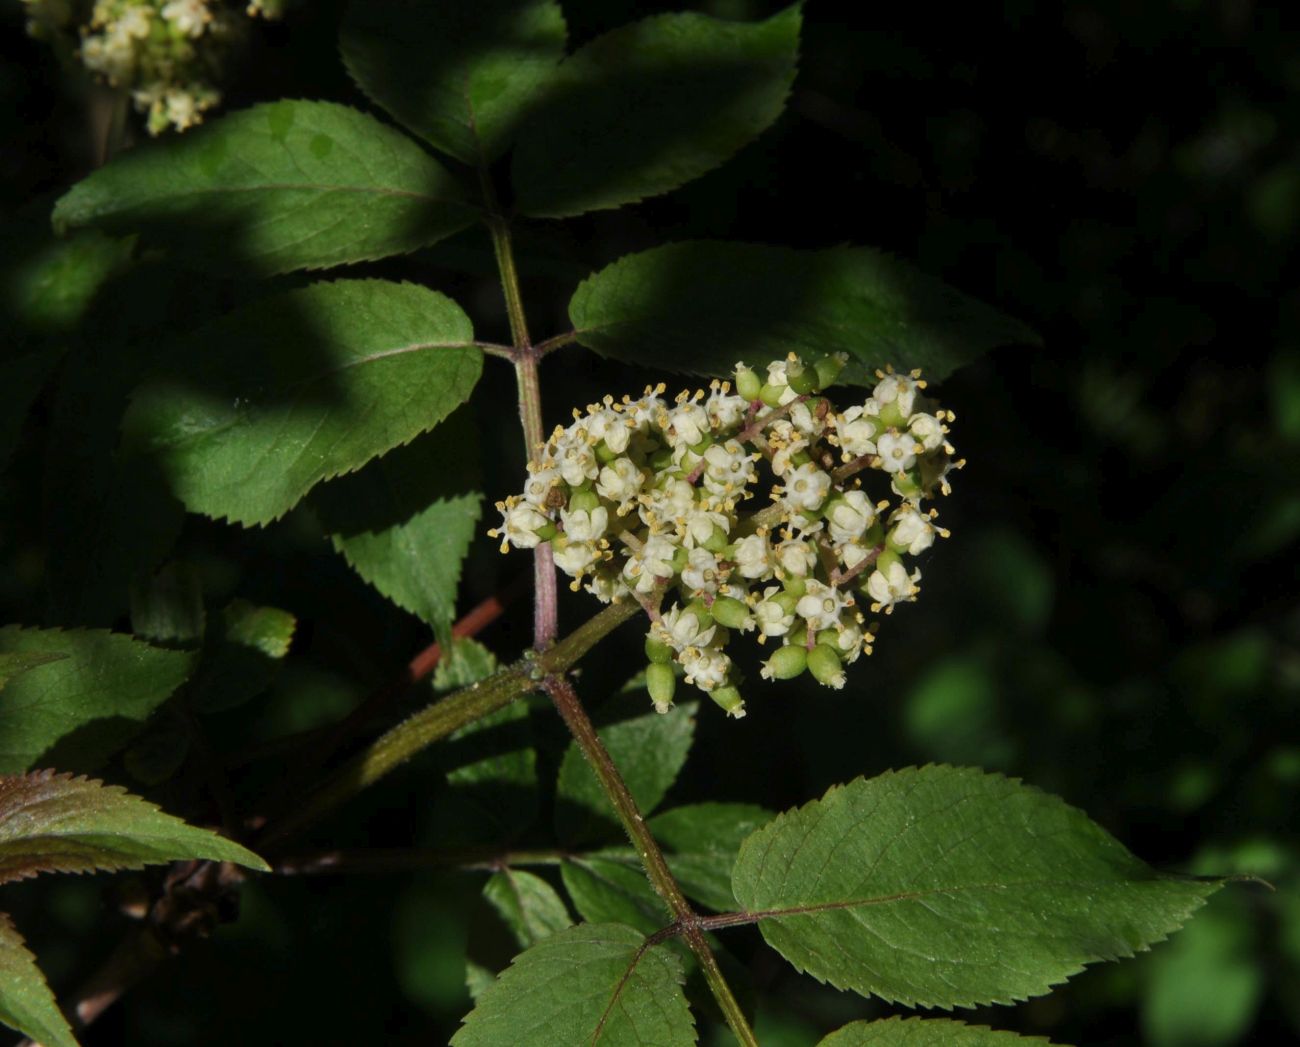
(732, 766), (1222, 1007)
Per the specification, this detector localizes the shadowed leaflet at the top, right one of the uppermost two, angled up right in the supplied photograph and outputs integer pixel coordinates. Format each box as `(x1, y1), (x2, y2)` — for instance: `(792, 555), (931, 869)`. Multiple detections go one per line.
(512, 5), (801, 219)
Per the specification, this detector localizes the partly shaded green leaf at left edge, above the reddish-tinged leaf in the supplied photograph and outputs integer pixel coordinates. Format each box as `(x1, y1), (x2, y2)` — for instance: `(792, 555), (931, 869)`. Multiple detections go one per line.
(0, 626), (194, 773)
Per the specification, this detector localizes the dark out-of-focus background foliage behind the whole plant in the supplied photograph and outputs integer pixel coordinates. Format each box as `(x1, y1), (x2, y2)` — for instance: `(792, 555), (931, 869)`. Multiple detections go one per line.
(0, 0), (1300, 1047)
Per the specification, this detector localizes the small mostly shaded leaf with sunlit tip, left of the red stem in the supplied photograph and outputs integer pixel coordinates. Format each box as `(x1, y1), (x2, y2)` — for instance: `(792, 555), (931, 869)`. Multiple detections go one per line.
(190, 600), (298, 713)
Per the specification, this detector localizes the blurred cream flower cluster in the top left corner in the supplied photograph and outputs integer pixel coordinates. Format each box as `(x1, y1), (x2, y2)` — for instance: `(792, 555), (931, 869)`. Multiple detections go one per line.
(23, 0), (282, 135)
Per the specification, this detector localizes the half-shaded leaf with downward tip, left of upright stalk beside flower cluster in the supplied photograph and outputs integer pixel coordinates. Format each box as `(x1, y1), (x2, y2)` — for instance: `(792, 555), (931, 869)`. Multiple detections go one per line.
(311, 411), (482, 649)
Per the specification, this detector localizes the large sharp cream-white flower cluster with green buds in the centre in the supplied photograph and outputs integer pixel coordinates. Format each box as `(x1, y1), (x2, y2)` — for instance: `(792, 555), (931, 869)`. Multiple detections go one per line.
(489, 354), (962, 717)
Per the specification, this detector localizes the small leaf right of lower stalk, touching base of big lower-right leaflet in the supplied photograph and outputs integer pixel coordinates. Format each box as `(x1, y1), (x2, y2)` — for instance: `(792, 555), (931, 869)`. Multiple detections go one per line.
(649, 804), (775, 912)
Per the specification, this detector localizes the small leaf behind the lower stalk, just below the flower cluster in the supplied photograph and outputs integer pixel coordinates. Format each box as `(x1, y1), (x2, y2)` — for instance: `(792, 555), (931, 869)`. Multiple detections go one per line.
(555, 702), (697, 842)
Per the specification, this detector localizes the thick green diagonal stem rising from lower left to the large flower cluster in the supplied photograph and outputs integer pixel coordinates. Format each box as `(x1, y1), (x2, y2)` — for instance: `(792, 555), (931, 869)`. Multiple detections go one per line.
(257, 601), (641, 849)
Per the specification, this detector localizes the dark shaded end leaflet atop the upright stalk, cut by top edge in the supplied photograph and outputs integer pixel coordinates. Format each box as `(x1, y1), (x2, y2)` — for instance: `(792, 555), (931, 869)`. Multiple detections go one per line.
(339, 0), (566, 165)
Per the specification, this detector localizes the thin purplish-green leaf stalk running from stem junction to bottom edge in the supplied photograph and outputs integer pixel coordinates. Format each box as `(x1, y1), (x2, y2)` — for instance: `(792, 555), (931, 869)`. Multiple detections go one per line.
(542, 674), (758, 1047)
